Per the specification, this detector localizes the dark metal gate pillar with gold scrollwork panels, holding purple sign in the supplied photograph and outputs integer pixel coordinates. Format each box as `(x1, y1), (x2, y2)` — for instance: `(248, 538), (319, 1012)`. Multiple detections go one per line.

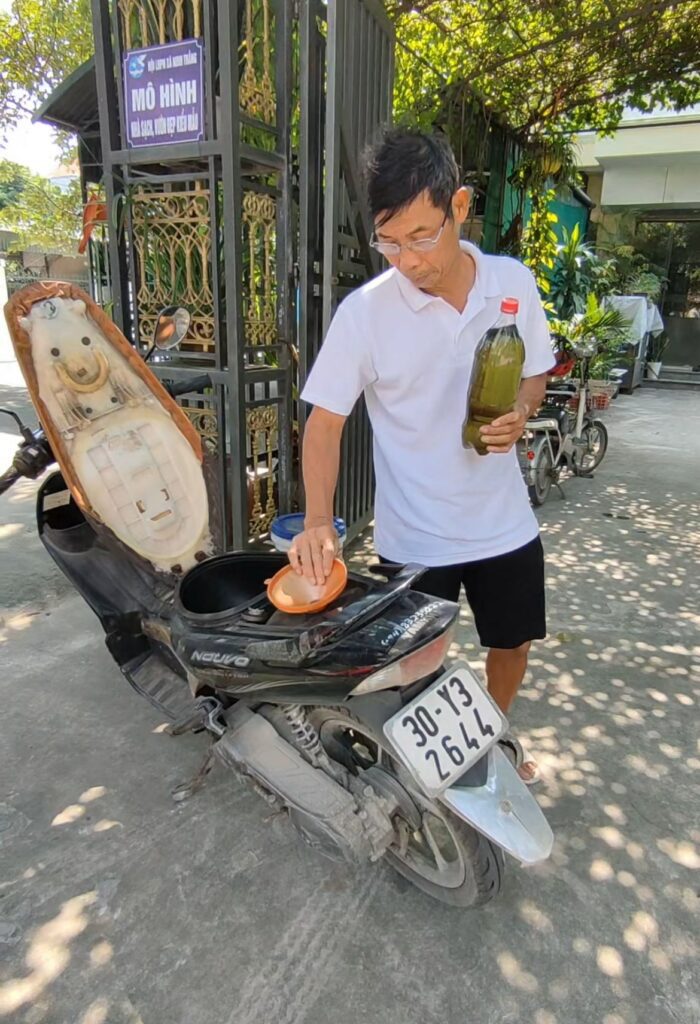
(92, 0), (294, 548)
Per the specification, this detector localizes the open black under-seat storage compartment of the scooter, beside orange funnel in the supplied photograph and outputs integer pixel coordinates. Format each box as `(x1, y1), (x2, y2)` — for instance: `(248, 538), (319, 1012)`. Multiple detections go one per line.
(176, 552), (288, 617)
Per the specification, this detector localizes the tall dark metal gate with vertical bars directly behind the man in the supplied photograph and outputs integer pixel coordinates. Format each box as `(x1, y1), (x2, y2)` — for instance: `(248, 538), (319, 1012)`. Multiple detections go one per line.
(300, 0), (394, 536)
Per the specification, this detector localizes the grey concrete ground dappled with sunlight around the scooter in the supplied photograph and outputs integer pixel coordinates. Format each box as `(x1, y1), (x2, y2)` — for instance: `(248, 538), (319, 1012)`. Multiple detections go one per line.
(0, 391), (700, 1024)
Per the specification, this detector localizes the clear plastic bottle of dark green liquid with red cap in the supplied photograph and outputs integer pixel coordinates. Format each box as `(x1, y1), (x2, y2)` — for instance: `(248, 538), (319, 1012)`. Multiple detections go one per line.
(462, 299), (525, 455)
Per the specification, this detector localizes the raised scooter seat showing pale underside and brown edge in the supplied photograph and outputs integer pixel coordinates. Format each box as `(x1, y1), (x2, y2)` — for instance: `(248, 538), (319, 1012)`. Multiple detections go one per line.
(5, 282), (212, 573)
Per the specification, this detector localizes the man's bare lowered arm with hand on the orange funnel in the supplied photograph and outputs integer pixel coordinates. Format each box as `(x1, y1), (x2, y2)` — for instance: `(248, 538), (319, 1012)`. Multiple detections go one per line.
(290, 406), (347, 585)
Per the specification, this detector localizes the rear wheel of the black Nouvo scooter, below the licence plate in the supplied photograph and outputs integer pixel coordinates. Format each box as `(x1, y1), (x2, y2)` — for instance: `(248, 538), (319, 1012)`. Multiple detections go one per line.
(308, 708), (505, 908)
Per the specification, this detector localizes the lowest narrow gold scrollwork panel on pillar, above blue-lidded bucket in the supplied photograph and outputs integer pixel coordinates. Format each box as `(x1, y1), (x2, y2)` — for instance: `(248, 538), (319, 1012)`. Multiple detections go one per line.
(246, 406), (278, 537)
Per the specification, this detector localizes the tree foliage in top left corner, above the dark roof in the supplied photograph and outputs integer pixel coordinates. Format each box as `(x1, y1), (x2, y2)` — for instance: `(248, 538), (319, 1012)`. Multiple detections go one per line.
(0, 0), (94, 137)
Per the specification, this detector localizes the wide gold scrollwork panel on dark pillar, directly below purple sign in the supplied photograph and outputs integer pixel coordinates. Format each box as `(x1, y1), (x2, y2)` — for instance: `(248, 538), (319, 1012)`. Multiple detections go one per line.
(130, 187), (216, 352)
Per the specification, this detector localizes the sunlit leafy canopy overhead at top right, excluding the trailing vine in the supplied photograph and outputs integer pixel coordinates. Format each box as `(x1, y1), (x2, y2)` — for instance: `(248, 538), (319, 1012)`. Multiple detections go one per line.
(388, 0), (700, 137)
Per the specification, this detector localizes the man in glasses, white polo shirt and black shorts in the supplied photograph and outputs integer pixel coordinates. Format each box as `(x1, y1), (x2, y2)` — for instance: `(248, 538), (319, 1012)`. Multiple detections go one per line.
(290, 129), (555, 782)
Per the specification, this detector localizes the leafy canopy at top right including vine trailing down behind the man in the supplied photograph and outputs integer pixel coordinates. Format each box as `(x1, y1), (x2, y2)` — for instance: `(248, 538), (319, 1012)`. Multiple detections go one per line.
(387, 0), (700, 276)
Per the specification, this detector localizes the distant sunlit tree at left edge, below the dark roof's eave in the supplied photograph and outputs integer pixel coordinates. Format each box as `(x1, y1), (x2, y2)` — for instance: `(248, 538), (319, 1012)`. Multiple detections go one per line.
(0, 160), (83, 255)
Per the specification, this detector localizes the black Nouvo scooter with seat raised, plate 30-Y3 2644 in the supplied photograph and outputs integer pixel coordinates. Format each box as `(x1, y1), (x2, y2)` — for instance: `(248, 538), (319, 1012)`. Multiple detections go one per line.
(0, 284), (553, 907)
